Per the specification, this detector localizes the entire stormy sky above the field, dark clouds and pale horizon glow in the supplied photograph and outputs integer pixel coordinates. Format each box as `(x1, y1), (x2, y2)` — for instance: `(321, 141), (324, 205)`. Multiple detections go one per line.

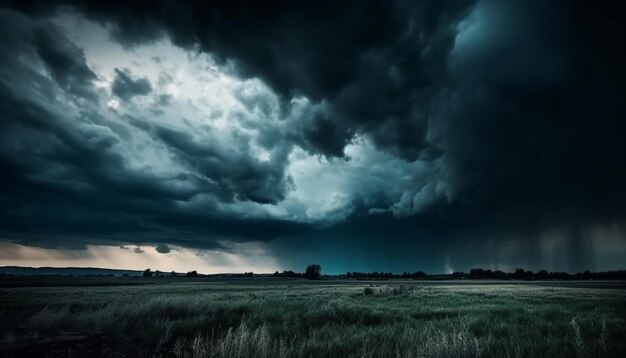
(0, 0), (626, 274)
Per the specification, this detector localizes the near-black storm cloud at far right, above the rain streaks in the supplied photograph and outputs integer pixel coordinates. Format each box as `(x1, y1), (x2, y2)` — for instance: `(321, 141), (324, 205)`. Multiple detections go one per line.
(431, 1), (626, 222)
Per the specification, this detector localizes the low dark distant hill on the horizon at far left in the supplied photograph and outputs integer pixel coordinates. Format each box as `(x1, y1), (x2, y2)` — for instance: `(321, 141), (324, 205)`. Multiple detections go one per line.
(0, 266), (142, 276)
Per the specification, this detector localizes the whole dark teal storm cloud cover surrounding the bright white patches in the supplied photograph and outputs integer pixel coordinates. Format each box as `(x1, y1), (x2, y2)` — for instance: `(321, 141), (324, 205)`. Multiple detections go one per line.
(0, 0), (626, 269)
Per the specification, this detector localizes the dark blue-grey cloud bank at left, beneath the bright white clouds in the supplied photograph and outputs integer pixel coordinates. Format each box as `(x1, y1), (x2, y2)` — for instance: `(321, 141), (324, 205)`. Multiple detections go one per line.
(0, 10), (302, 253)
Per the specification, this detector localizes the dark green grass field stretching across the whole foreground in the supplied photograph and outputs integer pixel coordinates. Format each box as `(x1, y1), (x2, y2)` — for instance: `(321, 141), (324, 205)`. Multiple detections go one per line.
(0, 278), (626, 357)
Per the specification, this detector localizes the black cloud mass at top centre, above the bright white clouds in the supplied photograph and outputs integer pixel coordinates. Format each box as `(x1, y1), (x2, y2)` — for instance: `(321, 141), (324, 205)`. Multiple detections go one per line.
(3, 1), (473, 159)
